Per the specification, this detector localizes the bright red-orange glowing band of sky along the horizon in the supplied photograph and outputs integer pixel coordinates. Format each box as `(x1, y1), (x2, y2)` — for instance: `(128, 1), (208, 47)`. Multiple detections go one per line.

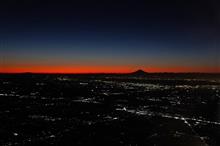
(0, 65), (220, 73)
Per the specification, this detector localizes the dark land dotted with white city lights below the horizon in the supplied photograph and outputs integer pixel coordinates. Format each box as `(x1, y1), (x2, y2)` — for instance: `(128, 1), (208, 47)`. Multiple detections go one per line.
(0, 74), (220, 146)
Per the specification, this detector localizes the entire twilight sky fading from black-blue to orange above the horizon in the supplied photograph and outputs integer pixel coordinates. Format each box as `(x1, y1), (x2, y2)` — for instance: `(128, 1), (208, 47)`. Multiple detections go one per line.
(0, 0), (220, 73)
